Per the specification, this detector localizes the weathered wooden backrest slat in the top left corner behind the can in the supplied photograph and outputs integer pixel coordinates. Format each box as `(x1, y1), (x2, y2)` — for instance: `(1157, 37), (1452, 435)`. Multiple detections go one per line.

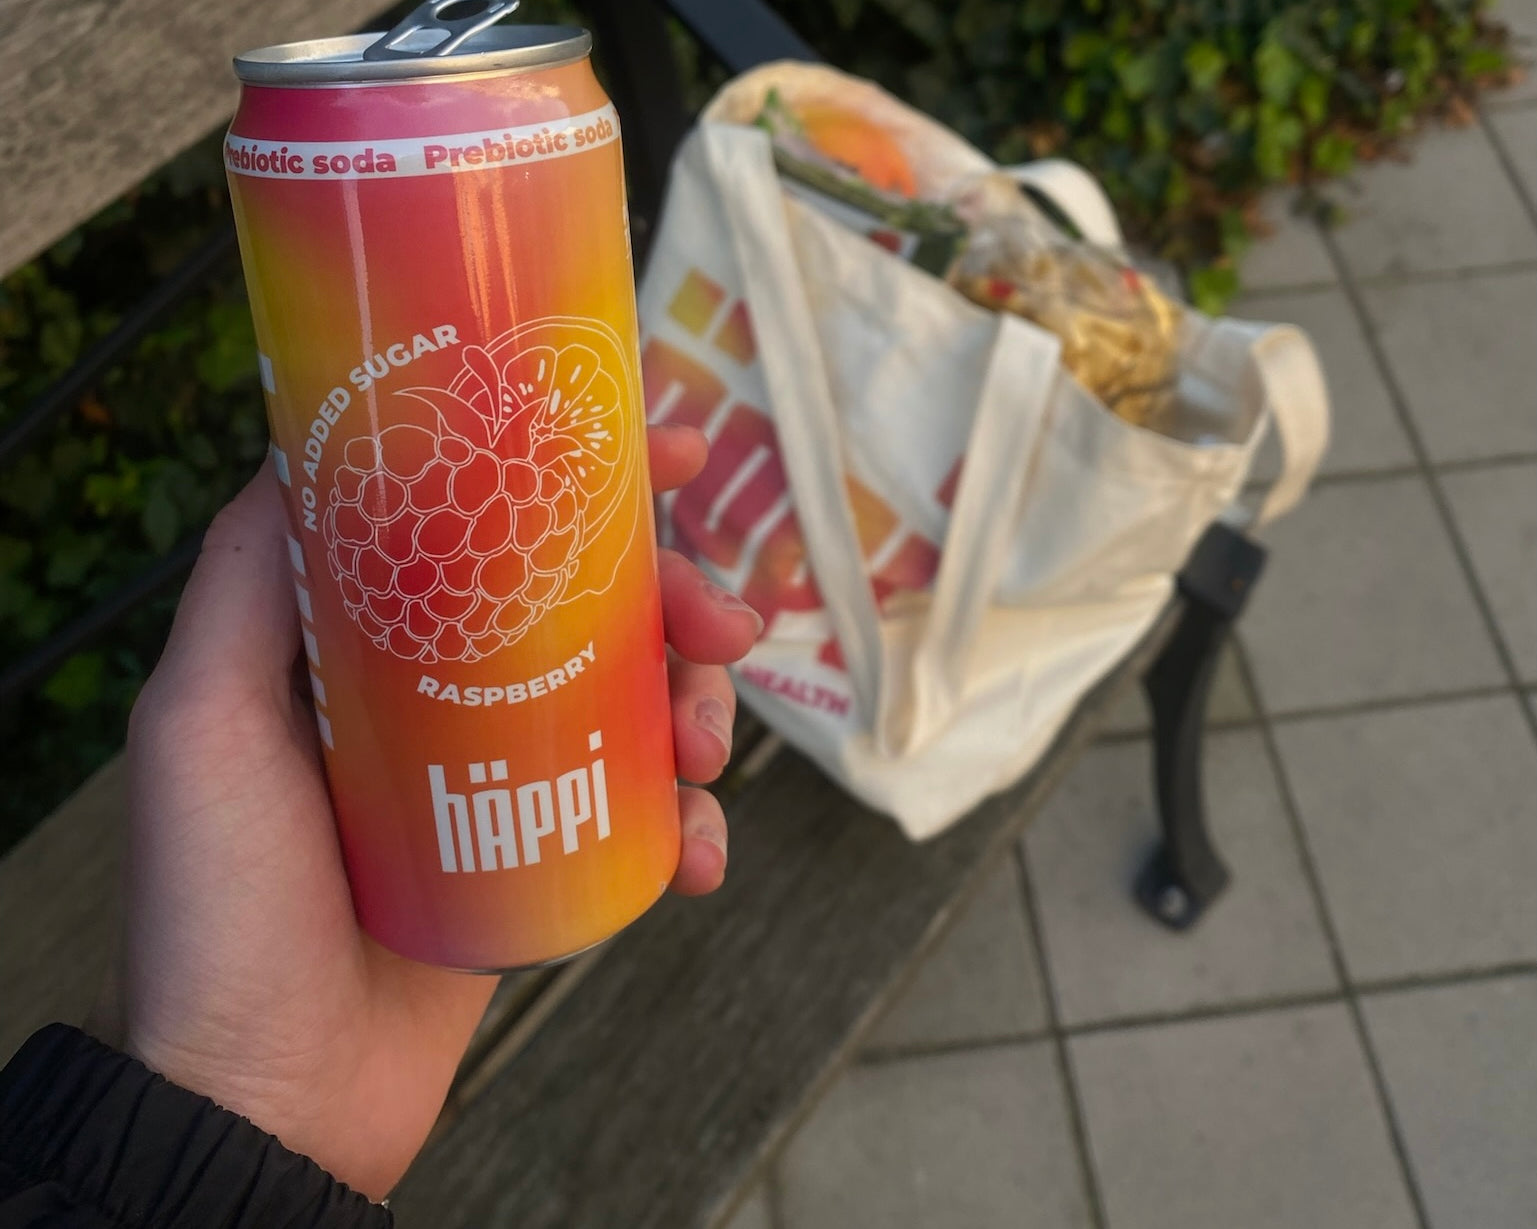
(0, 0), (386, 275)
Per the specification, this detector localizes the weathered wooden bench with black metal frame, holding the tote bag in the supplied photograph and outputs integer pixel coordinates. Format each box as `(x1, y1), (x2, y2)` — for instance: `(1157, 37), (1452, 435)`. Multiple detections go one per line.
(0, 0), (1263, 1229)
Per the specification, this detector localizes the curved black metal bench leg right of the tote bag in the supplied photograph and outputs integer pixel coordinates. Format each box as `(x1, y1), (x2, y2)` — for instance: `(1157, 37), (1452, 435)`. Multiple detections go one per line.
(1136, 524), (1265, 931)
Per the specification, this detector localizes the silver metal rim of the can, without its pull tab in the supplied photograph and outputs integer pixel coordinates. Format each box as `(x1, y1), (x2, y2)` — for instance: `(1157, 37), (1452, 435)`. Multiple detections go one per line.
(235, 25), (592, 86)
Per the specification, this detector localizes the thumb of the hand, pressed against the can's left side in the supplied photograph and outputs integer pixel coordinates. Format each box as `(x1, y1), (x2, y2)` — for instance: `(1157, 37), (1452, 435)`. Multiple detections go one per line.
(157, 461), (300, 693)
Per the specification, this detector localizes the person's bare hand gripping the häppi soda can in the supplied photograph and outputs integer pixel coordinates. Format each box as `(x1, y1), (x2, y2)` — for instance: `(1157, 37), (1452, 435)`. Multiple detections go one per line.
(97, 427), (761, 1198)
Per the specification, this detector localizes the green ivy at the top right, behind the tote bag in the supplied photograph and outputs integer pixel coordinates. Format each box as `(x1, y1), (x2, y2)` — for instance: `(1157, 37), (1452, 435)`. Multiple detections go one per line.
(776, 0), (1509, 298)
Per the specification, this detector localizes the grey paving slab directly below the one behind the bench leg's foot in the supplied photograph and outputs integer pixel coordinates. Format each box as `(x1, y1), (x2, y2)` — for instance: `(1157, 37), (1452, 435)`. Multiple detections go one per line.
(1071, 1003), (1416, 1229)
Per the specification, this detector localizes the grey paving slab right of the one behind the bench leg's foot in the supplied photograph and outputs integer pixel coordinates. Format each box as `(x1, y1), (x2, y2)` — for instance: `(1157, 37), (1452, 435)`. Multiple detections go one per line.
(1276, 694), (1537, 982)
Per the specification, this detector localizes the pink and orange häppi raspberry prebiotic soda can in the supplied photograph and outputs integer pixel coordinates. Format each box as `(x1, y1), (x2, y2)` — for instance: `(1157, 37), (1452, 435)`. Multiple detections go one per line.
(224, 0), (679, 971)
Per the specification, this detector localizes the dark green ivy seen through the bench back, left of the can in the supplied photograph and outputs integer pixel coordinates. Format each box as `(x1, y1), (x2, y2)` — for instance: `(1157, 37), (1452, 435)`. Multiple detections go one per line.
(0, 129), (266, 848)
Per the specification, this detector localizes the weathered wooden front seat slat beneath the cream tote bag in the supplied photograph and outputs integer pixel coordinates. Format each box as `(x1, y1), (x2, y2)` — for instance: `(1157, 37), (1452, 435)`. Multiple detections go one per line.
(392, 613), (1173, 1229)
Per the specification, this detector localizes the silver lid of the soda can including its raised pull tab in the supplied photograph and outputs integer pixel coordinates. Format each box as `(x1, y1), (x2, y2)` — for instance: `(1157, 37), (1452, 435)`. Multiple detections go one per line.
(235, 0), (592, 86)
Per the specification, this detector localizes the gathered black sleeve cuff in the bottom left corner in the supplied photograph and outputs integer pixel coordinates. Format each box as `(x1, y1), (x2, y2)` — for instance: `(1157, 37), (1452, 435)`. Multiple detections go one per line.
(0, 1025), (393, 1229)
